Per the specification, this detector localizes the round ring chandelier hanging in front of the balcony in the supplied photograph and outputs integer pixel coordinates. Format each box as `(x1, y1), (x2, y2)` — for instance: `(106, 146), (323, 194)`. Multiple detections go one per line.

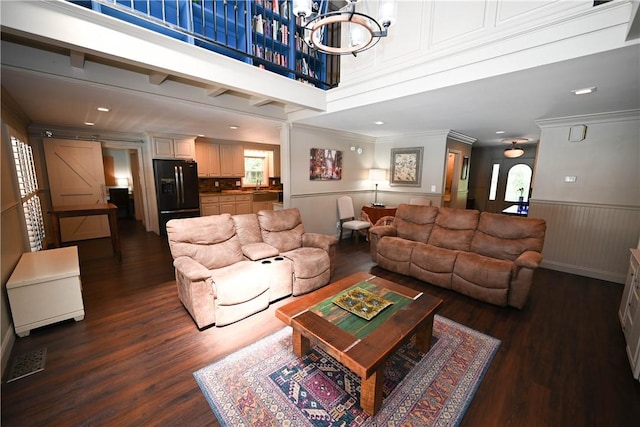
(293, 0), (396, 56)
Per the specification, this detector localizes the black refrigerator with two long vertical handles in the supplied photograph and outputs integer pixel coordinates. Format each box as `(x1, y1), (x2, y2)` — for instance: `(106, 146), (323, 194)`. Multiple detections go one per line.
(153, 159), (200, 235)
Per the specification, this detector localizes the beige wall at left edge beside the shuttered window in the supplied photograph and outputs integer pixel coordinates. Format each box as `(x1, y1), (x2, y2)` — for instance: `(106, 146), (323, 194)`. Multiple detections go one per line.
(0, 88), (28, 372)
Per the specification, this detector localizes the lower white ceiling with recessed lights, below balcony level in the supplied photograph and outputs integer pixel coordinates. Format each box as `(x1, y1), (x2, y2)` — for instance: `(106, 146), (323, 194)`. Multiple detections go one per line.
(1, 37), (640, 145)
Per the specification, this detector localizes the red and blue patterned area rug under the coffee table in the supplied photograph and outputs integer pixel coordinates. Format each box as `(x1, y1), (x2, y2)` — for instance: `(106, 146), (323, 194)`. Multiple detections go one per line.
(193, 315), (500, 427)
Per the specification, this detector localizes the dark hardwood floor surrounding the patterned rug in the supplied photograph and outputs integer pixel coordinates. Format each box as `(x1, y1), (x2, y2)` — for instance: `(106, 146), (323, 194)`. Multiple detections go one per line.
(1, 220), (640, 427)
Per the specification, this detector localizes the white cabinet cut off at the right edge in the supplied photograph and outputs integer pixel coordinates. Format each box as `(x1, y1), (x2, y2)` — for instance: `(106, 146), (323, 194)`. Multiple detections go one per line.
(618, 249), (640, 379)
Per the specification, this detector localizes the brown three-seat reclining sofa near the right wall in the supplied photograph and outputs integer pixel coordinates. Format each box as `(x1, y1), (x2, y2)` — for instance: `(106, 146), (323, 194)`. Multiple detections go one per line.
(369, 204), (546, 308)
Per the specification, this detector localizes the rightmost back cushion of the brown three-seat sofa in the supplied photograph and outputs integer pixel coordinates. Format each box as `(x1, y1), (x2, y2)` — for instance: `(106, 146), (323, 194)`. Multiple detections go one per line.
(471, 212), (546, 261)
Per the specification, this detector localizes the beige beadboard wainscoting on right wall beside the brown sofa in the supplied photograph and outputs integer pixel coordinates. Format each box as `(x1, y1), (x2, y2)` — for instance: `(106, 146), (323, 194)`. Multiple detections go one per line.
(529, 200), (640, 283)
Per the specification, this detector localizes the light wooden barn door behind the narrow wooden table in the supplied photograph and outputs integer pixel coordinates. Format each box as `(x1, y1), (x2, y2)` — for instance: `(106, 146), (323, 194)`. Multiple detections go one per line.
(43, 139), (110, 242)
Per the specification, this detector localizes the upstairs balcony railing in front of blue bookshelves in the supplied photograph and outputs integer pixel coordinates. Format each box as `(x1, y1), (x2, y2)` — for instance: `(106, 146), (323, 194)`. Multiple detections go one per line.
(69, 0), (339, 89)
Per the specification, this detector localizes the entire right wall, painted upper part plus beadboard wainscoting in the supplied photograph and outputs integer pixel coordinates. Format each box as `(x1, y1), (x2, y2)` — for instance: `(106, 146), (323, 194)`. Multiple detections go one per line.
(529, 111), (640, 283)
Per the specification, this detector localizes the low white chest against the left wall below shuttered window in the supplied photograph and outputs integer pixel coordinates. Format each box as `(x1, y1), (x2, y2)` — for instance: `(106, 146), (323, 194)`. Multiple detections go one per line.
(7, 246), (84, 337)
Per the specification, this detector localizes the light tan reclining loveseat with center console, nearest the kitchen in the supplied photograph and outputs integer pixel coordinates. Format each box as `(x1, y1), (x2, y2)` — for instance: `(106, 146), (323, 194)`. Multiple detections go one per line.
(167, 209), (338, 329)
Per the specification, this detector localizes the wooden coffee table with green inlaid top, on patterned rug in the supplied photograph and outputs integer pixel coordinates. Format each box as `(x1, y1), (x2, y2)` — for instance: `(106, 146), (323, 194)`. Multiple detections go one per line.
(276, 272), (442, 415)
